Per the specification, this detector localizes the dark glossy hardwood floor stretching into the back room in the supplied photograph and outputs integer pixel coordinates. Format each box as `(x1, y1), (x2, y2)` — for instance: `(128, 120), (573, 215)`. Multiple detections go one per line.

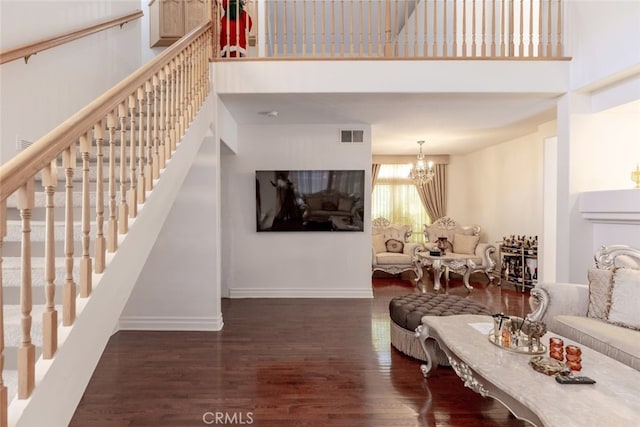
(70, 272), (529, 427)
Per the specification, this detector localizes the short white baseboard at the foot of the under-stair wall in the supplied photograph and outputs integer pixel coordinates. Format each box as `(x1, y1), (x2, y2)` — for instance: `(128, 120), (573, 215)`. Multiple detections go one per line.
(119, 315), (224, 331)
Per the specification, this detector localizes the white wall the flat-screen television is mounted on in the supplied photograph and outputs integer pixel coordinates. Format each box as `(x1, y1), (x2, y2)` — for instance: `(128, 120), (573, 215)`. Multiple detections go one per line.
(221, 124), (372, 298)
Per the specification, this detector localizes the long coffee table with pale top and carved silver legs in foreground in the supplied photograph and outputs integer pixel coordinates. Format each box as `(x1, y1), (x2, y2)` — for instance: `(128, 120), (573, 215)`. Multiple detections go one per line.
(416, 315), (640, 427)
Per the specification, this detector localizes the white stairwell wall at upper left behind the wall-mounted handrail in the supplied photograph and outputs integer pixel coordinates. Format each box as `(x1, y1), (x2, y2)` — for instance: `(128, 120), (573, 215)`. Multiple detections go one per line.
(0, 0), (141, 163)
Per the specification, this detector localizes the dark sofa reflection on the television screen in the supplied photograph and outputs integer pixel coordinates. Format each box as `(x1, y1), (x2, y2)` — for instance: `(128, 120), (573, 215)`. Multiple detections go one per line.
(302, 190), (361, 222)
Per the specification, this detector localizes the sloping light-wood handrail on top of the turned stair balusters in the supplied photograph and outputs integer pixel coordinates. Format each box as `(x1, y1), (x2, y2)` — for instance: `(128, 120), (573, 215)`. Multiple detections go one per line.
(0, 22), (211, 201)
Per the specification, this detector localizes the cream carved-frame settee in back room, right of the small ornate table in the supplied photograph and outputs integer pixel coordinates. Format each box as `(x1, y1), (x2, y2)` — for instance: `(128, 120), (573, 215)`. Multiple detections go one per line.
(424, 216), (496, 281)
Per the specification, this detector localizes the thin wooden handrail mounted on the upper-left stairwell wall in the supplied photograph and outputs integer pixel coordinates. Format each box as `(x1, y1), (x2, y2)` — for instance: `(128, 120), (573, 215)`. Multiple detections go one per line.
(0, 10), (143, 64)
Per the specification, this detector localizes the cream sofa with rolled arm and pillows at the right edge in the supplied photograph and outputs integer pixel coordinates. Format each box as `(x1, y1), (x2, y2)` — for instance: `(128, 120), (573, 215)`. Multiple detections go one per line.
(528, 245), (640, 370)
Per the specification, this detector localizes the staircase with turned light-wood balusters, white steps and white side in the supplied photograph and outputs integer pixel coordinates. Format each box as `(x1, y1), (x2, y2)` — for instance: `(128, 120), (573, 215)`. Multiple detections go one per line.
(0, 25), (213, 427)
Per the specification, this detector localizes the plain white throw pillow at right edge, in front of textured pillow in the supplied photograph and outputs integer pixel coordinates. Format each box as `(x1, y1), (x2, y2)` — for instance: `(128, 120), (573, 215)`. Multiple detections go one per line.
(608, 268), (640, 330)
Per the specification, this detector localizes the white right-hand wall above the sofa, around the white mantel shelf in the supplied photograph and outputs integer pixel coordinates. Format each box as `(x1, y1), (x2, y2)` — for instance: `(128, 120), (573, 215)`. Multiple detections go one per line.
(555, 0), (640, 283)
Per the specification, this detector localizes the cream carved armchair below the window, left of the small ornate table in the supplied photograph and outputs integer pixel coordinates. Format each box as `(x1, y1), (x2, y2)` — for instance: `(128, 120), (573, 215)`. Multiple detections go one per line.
(371, 218), (424, 277)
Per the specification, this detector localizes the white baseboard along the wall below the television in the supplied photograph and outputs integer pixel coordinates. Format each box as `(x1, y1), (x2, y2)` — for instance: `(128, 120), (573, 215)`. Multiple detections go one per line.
(229, 288), (373, 298)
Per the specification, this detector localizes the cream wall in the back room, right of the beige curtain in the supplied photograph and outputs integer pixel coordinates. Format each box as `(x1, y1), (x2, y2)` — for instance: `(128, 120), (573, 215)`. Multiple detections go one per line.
(447, 122), (555, 247)
